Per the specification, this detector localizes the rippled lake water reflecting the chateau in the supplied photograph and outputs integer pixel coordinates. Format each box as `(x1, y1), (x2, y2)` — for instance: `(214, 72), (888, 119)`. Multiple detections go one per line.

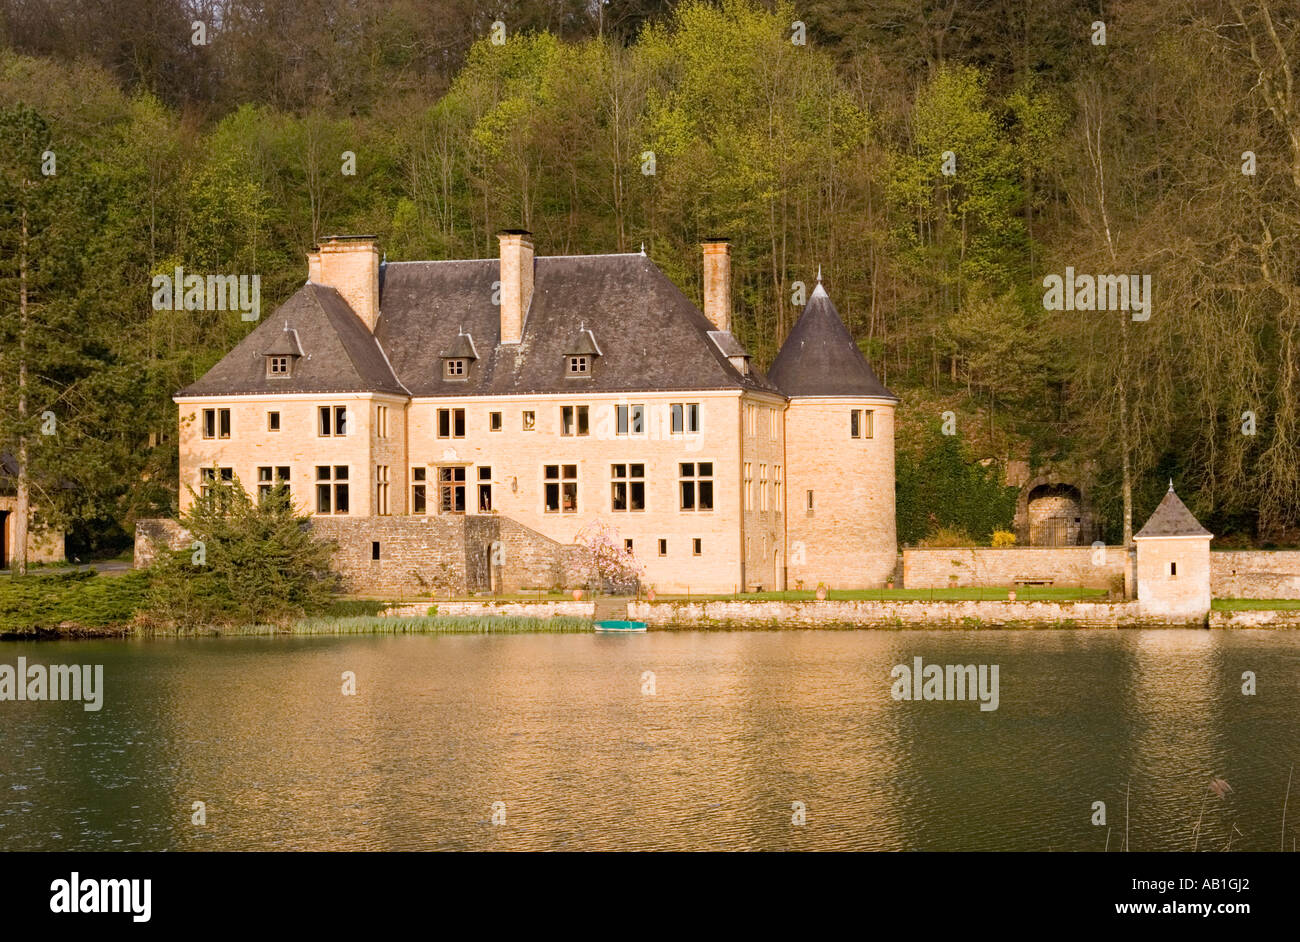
(0, 630), (1300, 851)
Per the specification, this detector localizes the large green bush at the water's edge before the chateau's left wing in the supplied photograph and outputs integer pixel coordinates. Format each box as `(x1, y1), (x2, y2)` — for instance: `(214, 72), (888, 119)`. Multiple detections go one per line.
(147, 478), (338, 628)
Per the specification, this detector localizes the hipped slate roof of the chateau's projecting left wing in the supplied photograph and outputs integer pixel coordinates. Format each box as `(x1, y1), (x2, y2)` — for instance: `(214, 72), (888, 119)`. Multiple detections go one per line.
(177, 282), (406, 396)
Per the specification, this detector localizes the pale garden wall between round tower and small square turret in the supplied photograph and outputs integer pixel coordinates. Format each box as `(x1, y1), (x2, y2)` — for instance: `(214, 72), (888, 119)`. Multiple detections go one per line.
(902, 546), (1126, 589)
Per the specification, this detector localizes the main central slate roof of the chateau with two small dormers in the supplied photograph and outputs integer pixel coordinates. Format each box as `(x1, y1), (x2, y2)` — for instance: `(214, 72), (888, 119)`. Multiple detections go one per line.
(376, 253), (777, 396)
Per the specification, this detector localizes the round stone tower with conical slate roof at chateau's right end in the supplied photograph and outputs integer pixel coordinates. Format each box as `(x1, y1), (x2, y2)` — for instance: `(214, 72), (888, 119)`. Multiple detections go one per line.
(767, 278), (898, 589)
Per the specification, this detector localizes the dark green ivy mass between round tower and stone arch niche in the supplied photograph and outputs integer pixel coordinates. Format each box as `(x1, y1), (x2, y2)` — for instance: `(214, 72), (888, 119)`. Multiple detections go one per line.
(896, 433), (1018, 544)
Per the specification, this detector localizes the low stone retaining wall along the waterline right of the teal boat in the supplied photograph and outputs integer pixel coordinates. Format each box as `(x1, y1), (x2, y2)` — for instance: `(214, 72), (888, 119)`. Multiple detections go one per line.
(628, 600), (1205, 629)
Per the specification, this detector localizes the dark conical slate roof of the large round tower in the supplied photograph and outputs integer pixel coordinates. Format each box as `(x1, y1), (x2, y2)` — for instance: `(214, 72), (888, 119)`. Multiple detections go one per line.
(767, 282), (898, 400)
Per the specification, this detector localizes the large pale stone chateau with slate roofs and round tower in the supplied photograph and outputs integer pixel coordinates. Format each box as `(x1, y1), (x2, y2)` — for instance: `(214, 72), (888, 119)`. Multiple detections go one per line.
(160, 230), (898, 592)
